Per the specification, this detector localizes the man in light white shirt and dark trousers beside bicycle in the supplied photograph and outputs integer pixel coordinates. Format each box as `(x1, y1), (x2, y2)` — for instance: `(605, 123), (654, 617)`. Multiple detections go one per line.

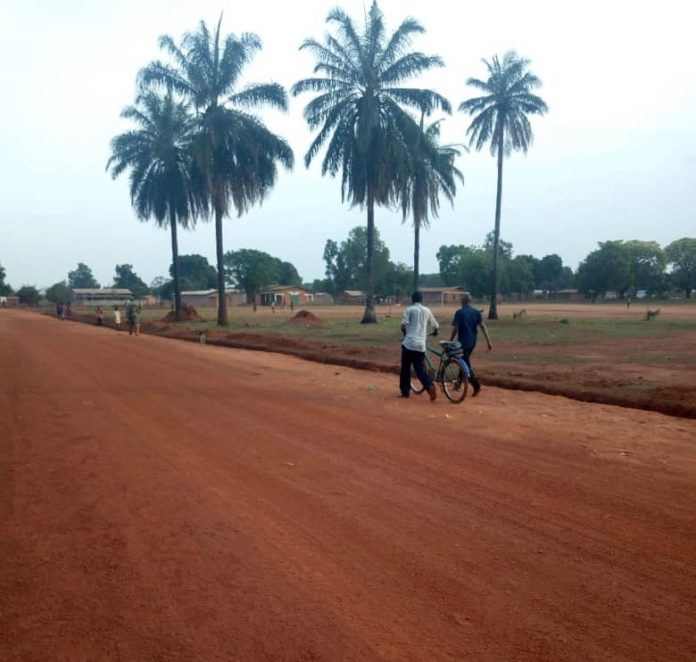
(399, 292), (440, 400)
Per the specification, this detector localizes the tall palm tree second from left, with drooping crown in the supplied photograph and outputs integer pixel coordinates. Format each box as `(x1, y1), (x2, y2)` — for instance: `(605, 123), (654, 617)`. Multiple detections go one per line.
(140, 17), (293, 326)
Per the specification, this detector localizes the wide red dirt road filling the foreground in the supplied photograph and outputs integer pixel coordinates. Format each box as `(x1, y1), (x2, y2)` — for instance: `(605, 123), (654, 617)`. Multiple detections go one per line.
(0, 312), (696, 662)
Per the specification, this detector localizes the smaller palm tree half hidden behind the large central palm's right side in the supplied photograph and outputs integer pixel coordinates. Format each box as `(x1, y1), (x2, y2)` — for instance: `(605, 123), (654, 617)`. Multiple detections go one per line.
(400, 111), (466, 290)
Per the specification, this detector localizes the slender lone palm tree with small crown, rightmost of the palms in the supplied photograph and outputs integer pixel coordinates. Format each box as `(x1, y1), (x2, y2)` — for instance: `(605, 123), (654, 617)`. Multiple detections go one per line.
(459, 51), (548, 319)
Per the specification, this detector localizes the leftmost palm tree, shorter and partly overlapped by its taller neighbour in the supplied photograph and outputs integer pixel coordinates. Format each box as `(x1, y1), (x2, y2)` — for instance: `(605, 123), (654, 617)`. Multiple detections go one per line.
(106, 92), (196, 321)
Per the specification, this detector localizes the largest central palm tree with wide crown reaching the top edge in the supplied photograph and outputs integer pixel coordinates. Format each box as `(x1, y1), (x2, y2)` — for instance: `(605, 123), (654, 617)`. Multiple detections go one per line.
(292, 2), (450, 323)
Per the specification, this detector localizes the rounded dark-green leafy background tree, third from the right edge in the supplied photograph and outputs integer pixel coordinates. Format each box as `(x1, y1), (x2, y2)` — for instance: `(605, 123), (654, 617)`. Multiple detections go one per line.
(576, 241), (631, 302)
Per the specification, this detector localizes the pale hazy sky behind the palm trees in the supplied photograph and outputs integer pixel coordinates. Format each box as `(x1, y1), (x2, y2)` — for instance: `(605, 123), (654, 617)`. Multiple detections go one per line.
(0, 0), (696, 288)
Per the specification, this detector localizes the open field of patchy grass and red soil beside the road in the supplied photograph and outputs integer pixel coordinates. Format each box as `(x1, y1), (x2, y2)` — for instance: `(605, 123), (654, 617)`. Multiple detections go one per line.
(68, 302), (696, 417)
